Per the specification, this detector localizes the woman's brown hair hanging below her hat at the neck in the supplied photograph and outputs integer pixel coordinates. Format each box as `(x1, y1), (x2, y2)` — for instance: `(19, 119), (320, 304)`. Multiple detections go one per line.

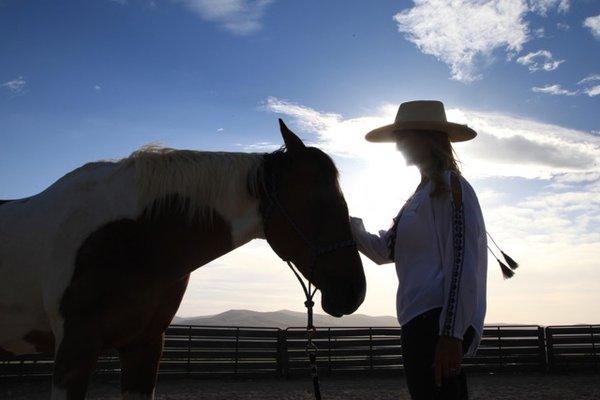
(419, 131), (460, 197)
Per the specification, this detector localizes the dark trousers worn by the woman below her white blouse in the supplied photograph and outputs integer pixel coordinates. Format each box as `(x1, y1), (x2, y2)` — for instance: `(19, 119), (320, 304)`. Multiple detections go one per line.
(402, 308), (475, 400)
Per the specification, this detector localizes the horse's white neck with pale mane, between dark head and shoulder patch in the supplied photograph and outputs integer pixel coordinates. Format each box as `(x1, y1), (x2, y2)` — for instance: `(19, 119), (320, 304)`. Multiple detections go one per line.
(136, 152), (264, 249)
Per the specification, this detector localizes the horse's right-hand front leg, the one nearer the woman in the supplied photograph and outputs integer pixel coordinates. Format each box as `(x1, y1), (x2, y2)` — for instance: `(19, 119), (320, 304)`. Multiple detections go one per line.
(119, 332), (164, 400)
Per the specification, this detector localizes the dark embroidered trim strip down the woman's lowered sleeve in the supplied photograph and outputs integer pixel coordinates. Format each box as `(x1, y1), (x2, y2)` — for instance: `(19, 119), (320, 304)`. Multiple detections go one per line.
(442, 198), (465, 336)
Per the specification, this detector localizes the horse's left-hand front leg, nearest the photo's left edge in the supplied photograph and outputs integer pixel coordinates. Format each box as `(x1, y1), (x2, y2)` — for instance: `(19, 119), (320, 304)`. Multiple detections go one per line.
(52, 322), (102, 400)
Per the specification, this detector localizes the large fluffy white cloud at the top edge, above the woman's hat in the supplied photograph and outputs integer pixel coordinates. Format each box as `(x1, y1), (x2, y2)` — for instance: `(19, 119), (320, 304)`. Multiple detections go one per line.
(394, 0), (529, 82)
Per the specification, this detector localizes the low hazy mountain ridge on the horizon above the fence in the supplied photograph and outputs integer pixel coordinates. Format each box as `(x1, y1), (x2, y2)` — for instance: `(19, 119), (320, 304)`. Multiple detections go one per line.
(172, 310), (399, 328)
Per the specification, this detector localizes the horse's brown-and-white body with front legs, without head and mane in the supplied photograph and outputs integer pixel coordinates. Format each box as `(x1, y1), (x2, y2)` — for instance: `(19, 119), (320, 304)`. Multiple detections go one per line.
(0, 153), (262, 399)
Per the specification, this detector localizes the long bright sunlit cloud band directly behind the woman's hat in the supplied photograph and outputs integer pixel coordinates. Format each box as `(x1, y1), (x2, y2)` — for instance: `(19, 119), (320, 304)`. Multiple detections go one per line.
(266, 97), (600, 179)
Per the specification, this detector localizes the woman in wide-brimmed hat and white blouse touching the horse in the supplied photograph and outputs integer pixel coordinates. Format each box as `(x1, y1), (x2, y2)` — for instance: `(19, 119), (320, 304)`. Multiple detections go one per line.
(351, 101), (487, 400)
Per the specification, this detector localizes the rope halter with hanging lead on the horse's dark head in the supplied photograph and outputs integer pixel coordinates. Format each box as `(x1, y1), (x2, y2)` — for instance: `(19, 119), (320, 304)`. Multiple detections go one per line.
(261, 162), (356, 400)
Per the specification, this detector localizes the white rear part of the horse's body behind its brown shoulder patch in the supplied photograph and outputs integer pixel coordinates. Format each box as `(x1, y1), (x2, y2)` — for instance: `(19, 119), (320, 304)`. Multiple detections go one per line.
(0, 159), (136, 354)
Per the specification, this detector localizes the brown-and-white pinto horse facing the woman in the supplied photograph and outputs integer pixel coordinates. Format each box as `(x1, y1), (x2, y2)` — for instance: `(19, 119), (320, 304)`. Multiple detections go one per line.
(0, 120), (366, 400)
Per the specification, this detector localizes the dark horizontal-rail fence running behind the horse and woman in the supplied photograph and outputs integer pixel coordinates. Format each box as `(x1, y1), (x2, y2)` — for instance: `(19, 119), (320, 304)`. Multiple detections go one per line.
(0, 325), (600, 377)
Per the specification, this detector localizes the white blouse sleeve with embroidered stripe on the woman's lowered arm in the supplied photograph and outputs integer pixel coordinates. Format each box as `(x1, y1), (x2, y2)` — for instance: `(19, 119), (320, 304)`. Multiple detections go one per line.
(434, 174), (481, 340)
